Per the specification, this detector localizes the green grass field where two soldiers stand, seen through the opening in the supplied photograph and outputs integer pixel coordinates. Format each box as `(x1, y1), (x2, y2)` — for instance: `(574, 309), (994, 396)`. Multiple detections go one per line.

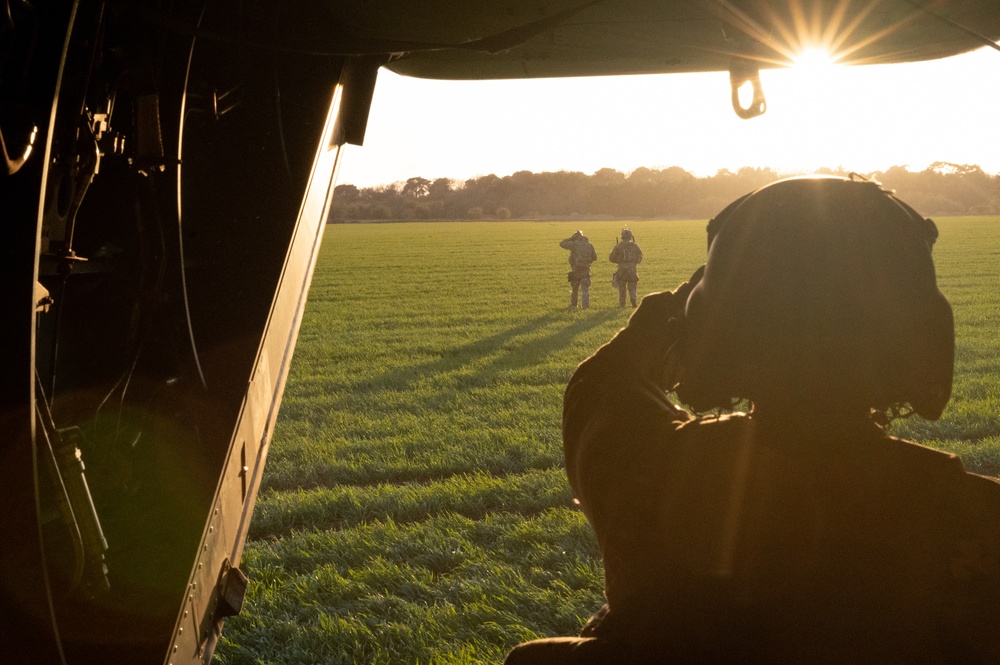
(215, 218), (1000, 665)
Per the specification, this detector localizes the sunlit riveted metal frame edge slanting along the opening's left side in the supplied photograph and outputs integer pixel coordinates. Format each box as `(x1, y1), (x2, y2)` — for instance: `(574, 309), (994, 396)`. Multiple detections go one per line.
(166, 58), (378, 665)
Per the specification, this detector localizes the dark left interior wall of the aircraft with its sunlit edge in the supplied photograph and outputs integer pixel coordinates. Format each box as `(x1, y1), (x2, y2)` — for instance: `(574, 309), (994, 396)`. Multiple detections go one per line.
(0, 0), (383, 664)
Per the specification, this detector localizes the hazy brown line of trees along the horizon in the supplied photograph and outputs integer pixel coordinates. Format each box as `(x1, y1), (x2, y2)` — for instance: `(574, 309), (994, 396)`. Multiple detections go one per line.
(330, 162), (1000, 222)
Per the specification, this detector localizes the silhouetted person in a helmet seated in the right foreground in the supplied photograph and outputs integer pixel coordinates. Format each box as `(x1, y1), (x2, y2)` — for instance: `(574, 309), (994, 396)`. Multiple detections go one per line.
(506, 177), (1000, 665)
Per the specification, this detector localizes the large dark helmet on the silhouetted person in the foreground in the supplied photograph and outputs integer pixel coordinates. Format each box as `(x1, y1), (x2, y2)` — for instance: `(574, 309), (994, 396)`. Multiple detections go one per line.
(678, 176), (954, 419)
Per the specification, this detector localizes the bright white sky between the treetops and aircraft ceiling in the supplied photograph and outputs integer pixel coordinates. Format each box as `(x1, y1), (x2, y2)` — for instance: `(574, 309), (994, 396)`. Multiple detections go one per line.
(337, 48), (1000, 187)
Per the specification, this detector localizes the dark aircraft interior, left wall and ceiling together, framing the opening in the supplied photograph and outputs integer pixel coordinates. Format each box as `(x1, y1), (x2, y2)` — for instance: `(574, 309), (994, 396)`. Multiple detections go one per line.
(0, 0), (1000, 665)
